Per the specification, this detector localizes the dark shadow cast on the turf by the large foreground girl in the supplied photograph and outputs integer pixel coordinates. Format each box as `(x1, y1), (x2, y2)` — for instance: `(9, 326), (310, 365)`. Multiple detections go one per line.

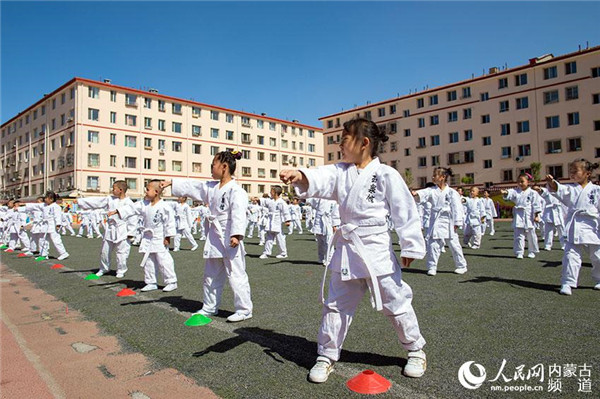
(192, 327), (406, 370)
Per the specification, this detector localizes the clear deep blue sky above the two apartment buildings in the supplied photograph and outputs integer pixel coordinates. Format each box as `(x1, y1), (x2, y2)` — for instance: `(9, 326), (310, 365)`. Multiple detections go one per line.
(0, 2), (600, 127)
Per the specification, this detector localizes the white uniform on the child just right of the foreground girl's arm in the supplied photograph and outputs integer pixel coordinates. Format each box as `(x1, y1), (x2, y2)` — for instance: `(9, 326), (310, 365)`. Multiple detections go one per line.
(416, 186), (467, 273)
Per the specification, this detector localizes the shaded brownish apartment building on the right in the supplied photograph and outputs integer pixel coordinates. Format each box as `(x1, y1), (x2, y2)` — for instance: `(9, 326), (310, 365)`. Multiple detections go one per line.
(320, 47), (600, 187)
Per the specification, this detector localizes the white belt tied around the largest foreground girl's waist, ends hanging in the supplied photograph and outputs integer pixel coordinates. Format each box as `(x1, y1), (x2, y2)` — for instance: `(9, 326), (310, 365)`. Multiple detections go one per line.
(321, 223), (387, 310)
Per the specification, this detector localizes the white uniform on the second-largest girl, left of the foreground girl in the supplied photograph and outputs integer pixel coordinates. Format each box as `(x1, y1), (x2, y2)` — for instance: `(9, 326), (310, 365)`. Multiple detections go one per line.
(172, 179), (252, 315)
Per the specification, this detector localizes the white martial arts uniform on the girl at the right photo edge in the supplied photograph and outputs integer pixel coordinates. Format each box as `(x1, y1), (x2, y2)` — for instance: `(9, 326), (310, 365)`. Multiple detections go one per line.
(552, 182), (600, 288)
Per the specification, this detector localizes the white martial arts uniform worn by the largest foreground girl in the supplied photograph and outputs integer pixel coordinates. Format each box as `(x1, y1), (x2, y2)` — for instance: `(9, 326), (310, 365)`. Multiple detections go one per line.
(295, 158), (425, 361)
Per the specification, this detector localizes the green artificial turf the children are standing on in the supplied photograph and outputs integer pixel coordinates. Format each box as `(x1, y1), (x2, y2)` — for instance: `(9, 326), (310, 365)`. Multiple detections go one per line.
(2, 223), (600, 398)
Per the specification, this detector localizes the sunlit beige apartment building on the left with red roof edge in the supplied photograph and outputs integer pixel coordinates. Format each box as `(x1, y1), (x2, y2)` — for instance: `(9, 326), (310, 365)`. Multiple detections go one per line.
(0, 78), (323, 198)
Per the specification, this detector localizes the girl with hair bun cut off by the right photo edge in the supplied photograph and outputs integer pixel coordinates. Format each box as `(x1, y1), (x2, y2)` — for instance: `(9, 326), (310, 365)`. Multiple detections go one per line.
(546, 159), (600, 295)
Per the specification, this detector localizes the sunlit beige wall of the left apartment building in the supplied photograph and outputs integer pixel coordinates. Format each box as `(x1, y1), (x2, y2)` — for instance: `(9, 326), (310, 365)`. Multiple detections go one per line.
(0, 78), (323, 196)
